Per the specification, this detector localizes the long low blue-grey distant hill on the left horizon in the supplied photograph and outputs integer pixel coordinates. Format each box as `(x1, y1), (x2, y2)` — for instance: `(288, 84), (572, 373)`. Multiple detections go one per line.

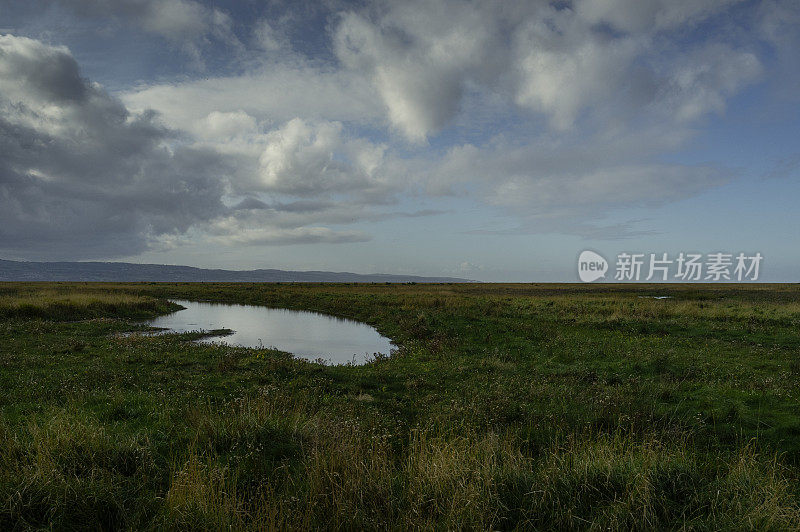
(0, 260), (472, 283)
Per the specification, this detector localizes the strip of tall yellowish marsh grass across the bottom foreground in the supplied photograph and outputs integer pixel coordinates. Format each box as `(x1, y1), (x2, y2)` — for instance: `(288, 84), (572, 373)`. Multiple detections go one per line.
(7, 397), (800, 530)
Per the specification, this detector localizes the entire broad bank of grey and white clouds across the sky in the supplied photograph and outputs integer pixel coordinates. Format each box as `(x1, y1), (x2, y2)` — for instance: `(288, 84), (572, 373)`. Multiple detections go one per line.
(0, 0), (799, 258)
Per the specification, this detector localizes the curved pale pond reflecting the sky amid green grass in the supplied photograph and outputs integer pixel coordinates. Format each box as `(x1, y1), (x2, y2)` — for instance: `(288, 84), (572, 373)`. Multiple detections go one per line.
(147, 300), (394, 364)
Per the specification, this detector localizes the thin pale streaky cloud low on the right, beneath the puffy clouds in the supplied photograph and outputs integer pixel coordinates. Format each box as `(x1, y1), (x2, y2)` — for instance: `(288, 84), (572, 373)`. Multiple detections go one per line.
(426, 130), (734, 237)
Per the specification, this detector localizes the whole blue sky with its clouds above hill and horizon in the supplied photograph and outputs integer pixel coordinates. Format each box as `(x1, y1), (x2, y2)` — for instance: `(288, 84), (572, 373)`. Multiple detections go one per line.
(0, 0), (800, 282)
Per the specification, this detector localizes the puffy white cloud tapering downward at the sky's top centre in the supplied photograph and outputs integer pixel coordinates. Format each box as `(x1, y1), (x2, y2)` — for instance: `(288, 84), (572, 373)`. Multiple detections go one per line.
(334, 1), (501, 141)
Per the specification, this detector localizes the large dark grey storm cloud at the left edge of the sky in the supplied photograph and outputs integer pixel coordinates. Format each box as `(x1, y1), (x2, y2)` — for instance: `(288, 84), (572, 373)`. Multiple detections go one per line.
(0, 36), (231, 257)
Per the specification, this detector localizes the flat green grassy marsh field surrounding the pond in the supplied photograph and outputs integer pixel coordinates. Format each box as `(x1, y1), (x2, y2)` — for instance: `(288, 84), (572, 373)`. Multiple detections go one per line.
(0, 283), (800, 530)
